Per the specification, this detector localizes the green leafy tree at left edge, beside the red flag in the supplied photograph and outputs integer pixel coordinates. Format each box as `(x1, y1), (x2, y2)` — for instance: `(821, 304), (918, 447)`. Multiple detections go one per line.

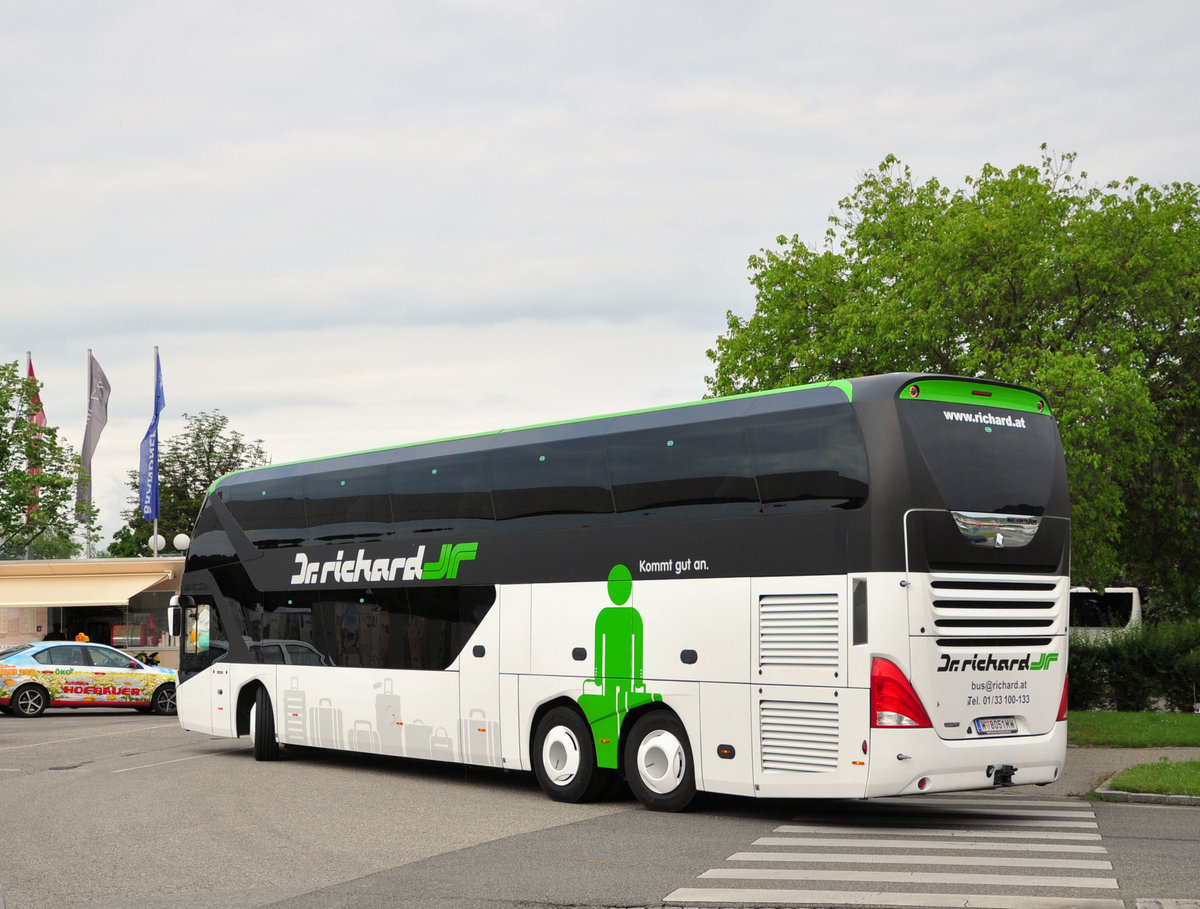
(0, 361), (83, 559)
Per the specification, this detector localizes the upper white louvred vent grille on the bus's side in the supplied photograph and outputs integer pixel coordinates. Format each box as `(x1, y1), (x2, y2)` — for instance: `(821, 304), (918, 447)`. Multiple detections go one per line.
(758, 594), (841, 668)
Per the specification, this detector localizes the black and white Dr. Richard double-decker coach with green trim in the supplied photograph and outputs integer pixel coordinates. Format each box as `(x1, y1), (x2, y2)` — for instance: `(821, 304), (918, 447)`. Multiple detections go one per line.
(173, 374), (1069, 811)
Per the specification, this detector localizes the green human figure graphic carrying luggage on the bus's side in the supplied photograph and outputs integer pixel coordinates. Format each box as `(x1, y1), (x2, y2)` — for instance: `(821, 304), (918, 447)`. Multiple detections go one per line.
(580, 565), (662, 770)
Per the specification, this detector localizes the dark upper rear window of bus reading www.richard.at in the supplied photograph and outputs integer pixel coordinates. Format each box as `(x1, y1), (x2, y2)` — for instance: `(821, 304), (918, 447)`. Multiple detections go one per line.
(899, 401), (1061, 514)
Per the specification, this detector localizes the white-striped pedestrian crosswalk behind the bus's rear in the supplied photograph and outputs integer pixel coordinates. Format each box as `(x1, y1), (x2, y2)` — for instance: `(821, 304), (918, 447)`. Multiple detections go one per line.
(665, 795), (1124, 909)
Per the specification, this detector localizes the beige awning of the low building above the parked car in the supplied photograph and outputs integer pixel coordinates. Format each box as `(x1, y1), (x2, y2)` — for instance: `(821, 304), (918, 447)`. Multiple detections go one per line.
(0, 556), (184, 608)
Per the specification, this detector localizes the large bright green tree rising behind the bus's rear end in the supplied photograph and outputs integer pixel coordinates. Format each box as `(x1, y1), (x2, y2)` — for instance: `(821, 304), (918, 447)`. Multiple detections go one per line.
(708, 146), (1200, 612)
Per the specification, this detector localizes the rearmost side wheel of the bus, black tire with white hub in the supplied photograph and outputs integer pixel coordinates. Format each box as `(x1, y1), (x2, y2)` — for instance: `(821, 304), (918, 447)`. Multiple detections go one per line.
(625, 710), (696, 811)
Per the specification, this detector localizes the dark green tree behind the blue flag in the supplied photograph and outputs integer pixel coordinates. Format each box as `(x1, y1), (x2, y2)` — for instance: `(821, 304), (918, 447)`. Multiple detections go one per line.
(108, 411), (268, 556)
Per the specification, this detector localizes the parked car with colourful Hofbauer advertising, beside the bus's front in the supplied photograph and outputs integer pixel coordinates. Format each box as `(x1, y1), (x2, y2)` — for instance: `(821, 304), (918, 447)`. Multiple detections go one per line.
(0, 640), (175, 716)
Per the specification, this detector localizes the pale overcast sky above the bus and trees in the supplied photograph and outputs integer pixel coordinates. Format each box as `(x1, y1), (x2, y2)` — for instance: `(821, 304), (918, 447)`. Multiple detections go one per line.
(0, 0), (1200, 544)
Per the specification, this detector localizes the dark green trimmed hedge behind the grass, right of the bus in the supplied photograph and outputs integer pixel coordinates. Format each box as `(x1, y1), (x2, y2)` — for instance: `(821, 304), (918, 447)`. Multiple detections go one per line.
(1069, 622), (1200, 712)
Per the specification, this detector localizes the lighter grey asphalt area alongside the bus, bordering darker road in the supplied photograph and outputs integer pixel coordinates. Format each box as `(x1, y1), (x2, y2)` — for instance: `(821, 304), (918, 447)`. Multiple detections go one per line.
(0, 709), (637, 909)
